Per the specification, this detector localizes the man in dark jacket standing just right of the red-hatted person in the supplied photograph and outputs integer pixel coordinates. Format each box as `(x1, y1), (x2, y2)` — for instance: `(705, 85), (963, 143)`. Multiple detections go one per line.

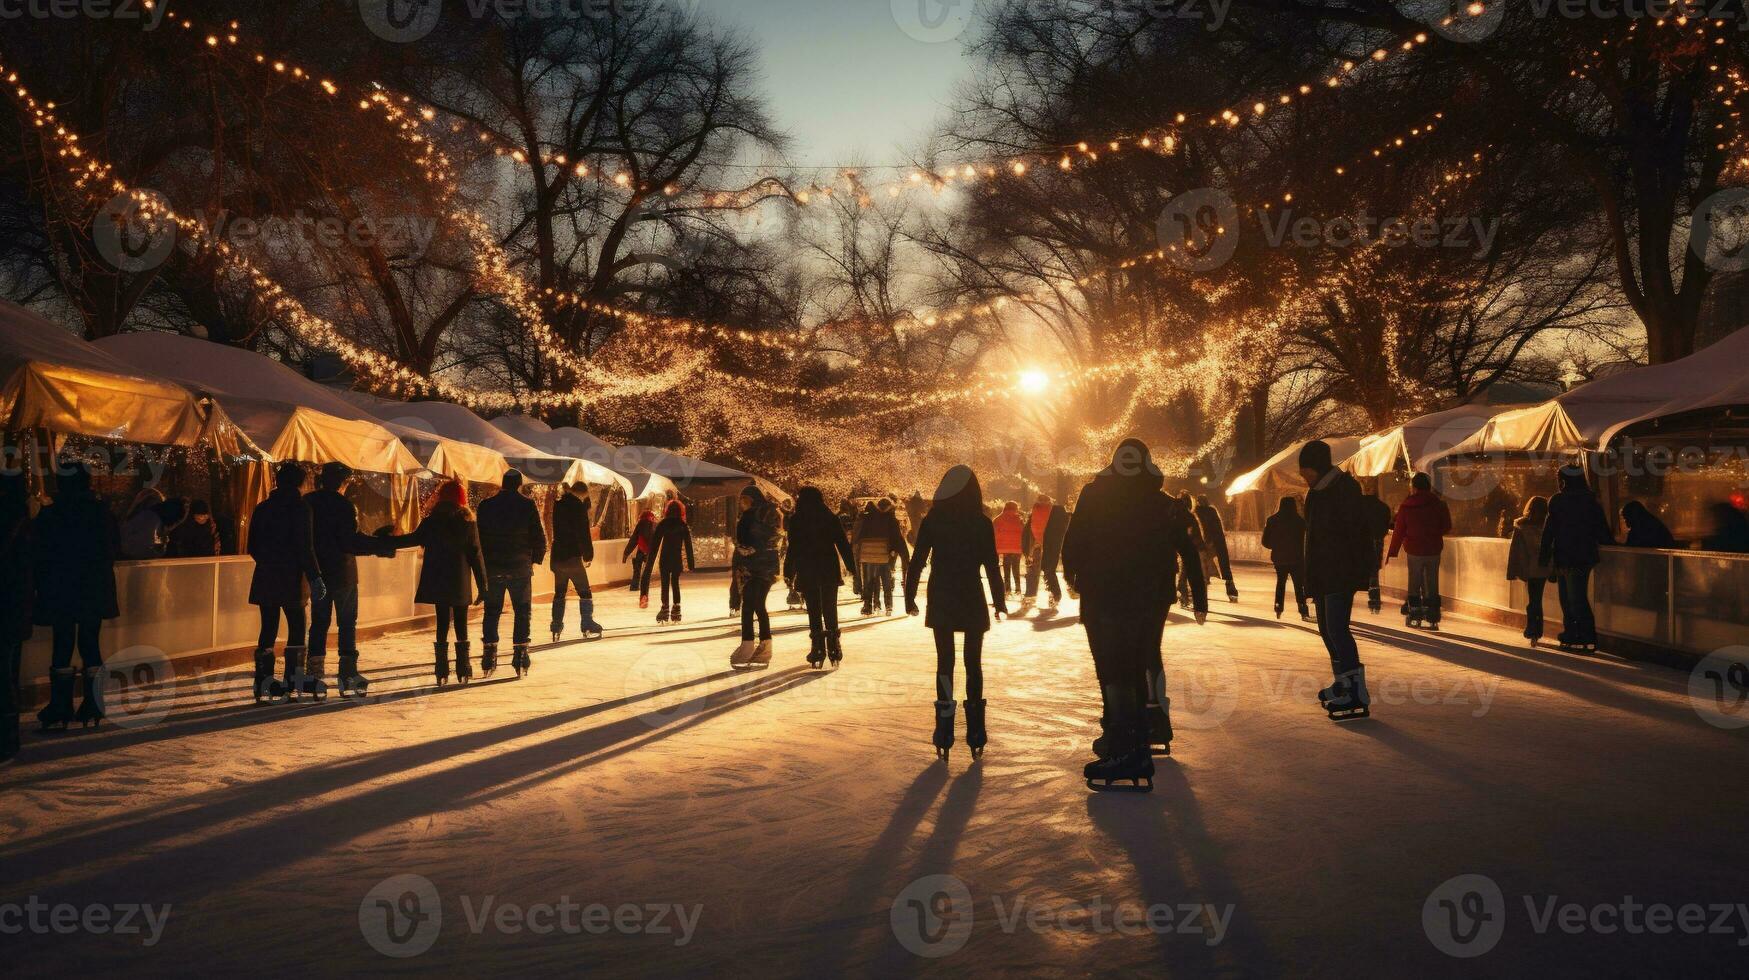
(474, 469), (545, 677)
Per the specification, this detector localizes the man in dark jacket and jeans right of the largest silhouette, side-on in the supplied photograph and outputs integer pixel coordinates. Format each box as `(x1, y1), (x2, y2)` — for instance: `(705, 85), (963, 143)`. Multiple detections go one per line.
(1300, 441), (1378, 719)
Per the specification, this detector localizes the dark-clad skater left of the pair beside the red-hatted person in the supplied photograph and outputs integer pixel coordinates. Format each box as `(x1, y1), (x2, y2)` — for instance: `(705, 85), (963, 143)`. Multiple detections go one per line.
(248, 462), (327, 704)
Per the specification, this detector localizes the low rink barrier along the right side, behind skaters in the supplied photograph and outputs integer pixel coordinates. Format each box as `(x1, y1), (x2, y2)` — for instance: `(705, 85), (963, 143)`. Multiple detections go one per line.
(1228, 532), (1749, 667)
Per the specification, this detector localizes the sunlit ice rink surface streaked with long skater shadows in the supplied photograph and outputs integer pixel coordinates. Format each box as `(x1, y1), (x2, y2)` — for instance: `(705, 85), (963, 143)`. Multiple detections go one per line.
(0, 571), (1749, 977)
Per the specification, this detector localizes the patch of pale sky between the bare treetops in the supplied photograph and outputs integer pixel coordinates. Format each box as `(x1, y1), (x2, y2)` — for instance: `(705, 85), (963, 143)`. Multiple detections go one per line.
(698, 0), (976, 166)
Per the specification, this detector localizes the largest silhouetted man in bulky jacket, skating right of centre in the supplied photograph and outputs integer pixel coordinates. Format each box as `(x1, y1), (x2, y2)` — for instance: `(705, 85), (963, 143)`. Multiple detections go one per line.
(1062, 439), (1209, 789)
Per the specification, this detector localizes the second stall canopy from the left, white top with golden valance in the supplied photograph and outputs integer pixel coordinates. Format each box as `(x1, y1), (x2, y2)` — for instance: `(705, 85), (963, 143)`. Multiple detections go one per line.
(96, 333), (423, 476)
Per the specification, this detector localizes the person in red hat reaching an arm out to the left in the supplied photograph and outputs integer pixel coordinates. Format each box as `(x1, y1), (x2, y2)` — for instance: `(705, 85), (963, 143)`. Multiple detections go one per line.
(378, 480), (486, 688)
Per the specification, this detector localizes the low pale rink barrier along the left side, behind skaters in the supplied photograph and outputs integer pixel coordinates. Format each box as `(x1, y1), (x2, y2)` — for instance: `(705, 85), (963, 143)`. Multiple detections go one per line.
(21, 539), (650, 704)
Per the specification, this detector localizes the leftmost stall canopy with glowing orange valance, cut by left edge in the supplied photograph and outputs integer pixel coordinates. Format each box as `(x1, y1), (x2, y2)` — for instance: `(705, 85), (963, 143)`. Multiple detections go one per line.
(0, 301), (224, 446)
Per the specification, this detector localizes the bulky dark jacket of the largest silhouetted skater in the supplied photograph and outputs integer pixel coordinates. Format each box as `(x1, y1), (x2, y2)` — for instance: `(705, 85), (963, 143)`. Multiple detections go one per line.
(1063, 469), (1209, 620)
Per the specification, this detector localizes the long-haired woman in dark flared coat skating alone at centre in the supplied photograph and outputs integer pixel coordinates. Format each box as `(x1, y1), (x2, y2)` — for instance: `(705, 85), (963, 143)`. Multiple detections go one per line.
(904, 466), (1020, 761)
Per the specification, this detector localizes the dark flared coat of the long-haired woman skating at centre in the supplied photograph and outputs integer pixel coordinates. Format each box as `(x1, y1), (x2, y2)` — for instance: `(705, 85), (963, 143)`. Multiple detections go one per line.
(904, 508), (1020, 634)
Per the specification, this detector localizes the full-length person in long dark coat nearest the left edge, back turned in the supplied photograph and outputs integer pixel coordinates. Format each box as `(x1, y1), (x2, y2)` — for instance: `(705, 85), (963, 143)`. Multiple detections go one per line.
(31, 462), (121, 730)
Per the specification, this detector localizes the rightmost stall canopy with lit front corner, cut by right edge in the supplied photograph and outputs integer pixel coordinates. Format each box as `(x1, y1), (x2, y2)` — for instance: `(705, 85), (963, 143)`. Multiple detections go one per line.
(1429, 331), (1749, 462)
